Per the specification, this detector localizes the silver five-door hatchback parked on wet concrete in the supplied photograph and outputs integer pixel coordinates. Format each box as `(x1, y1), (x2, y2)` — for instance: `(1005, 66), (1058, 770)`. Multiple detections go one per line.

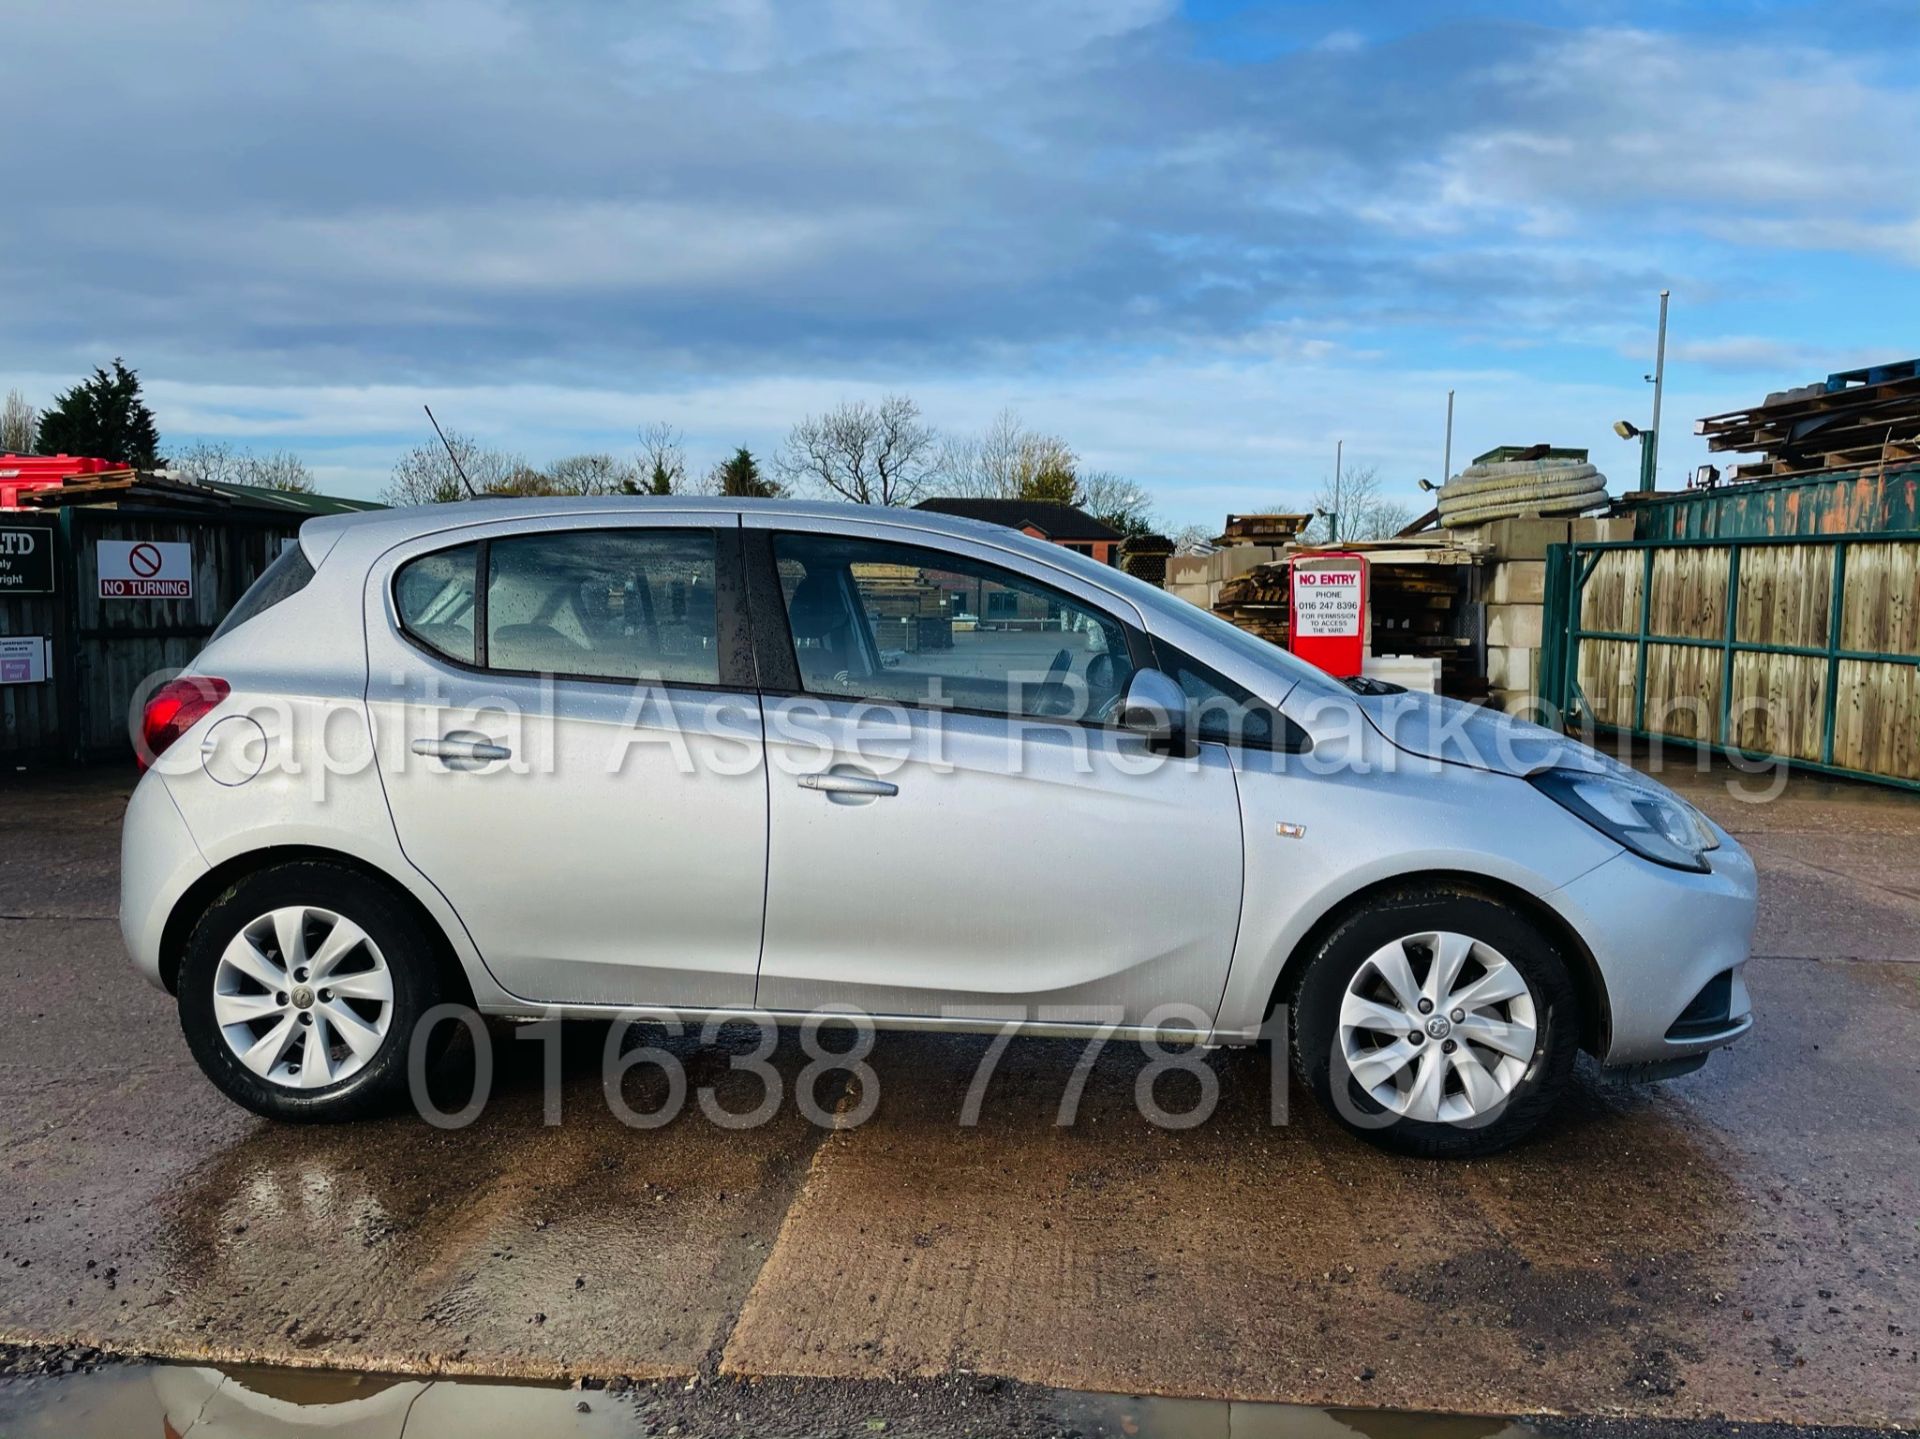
(121, 498), (1755, 1155)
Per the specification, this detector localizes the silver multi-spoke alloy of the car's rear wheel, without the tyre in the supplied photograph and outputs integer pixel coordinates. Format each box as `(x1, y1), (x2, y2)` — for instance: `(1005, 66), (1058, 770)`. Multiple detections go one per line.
(213, 905), (394, 1089)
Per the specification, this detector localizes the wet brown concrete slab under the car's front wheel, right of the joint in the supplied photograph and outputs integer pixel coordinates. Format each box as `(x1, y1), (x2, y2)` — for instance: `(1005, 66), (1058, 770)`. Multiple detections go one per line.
(724, 961), (1920, 1424)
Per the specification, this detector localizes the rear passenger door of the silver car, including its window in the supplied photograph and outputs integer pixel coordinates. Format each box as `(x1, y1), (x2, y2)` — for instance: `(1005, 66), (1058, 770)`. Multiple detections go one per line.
(367, 515), (766, 1007)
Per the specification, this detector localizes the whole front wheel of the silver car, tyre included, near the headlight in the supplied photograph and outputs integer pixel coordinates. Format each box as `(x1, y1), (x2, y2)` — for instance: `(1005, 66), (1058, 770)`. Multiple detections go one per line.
(1292, 886), (1580, 1159)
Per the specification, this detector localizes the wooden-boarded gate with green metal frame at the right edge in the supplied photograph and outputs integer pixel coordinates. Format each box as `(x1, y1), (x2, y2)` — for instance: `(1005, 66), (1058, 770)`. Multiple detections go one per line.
(1540, 532), (1920, 790)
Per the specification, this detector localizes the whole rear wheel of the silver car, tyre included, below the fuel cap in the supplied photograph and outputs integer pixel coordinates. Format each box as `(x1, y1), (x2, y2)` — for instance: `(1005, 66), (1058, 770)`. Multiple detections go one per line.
(179, 863), (440, 1120)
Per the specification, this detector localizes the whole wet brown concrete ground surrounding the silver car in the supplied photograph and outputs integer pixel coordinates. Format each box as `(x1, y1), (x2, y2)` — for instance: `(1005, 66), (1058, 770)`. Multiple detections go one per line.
(0, 772), (1920, 1426)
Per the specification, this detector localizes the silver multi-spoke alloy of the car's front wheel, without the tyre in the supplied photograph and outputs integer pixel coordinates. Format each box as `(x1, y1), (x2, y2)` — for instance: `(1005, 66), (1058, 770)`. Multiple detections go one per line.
(1338, 930), (1540, 1124)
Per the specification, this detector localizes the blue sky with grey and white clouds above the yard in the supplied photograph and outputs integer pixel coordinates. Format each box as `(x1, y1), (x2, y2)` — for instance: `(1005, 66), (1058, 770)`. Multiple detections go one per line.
(0, 0), (1920, 524)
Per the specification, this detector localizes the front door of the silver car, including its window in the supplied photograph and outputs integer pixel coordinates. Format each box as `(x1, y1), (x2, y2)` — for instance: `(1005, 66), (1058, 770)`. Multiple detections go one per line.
(747, 515), (1240, 1026)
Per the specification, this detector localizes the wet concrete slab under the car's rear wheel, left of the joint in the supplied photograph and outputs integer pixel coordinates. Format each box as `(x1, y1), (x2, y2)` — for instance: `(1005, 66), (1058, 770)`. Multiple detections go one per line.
(0, 891), (818, 1378)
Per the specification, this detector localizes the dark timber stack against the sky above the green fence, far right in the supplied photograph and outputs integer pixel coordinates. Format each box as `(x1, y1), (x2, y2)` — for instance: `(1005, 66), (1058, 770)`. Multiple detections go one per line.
(1693, 359), (1920, 480)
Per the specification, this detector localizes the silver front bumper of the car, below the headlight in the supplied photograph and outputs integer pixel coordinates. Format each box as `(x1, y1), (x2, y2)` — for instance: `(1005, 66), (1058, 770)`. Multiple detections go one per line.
(1548, 834), (1755, 1066)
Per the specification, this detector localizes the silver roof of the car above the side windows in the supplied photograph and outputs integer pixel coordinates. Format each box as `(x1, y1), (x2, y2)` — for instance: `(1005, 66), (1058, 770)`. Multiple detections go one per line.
(300, 494), (1054, 565)
